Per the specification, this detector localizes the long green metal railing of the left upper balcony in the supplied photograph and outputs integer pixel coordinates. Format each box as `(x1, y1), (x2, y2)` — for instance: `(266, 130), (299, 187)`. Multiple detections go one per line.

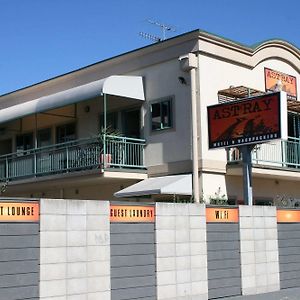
(0, 135), (145, 180)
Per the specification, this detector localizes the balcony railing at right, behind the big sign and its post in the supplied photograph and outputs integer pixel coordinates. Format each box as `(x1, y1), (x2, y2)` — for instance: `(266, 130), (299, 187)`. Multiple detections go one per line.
(227, 138), (300, 170)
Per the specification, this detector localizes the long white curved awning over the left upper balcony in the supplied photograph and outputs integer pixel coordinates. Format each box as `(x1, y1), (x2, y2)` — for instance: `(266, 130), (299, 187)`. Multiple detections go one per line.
(0, 75), (145, 123)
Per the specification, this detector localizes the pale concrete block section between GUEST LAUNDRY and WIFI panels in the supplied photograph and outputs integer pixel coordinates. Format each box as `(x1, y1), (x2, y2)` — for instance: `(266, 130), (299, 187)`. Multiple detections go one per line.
(156, 203), (208, 300)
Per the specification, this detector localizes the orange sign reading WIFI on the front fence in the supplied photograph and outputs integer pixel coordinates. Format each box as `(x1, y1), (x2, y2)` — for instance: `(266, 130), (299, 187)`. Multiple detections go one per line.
(206, 207), (239, 223)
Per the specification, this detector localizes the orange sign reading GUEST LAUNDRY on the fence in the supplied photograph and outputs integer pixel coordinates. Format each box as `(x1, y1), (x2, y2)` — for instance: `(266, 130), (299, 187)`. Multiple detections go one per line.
(110, 205), (155, 223)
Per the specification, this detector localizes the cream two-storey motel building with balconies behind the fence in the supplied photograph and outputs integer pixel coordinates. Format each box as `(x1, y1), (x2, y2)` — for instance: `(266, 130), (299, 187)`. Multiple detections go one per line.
(0, 30), (300, 203)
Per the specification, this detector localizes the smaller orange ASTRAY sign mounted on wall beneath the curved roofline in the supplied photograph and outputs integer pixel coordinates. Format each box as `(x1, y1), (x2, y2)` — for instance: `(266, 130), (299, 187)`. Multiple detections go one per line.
(265, 68), (297, 100)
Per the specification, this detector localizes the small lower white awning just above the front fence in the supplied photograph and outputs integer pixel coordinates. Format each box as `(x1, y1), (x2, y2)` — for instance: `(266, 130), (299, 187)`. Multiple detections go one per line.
(114, 174), (192, 198)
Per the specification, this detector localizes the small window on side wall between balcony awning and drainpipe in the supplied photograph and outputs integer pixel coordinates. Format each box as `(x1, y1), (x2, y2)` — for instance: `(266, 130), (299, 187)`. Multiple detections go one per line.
(151, 99), (173, 131)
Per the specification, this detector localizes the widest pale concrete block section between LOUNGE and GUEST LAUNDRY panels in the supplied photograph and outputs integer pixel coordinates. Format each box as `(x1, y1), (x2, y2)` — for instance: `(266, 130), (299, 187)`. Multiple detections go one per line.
(40, 199), (110, 300)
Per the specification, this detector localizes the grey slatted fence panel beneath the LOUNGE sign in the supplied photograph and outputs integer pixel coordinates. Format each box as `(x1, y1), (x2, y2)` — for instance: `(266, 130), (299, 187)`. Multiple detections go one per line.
(0, 222), (40, 300)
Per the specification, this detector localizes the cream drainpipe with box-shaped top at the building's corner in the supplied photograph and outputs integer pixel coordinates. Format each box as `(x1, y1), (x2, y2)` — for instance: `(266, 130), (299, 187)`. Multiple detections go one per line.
(179, 53), (200, 203)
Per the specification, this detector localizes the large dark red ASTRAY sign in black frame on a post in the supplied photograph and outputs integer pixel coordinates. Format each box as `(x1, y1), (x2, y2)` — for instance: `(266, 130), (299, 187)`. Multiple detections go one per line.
(207, 92), (287, 149)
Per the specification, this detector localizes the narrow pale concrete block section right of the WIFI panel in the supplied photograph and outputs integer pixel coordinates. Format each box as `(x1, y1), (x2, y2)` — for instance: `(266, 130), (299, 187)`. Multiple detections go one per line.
(239, 206), (280, 295)
